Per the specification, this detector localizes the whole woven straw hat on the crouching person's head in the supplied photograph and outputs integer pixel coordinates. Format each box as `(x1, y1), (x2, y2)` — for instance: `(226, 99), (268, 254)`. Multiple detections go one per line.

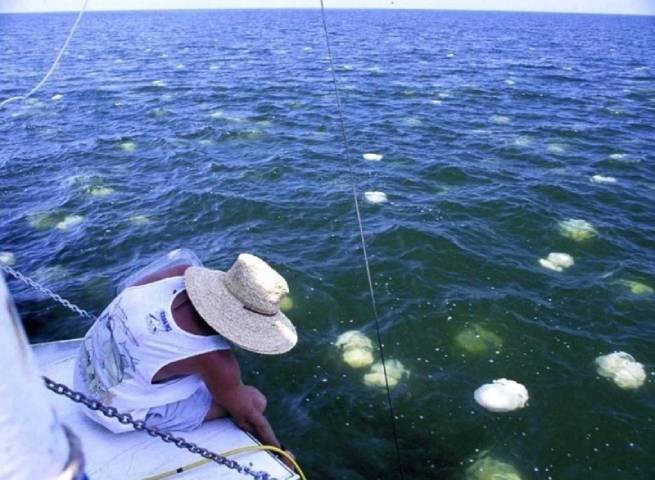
(184, 253), (298, 355)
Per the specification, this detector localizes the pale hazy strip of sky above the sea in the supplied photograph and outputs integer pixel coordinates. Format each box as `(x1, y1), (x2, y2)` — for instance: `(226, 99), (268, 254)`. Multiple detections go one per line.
(0, 0), (655, 15)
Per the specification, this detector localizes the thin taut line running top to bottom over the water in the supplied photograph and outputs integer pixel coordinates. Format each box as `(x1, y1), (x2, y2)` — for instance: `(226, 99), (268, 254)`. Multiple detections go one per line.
(320, 0), (404, 479)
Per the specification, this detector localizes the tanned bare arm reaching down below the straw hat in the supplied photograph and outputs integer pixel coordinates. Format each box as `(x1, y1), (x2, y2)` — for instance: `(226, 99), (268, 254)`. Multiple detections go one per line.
(198, 350), (280, 448)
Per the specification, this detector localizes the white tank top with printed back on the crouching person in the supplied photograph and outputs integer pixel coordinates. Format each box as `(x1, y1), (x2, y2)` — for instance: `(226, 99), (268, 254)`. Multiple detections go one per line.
(74, 277), (230, 432)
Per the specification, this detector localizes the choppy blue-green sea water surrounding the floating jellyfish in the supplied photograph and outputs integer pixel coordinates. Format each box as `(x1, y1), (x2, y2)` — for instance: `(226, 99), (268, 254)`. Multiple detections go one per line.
(0, 10), (655, 479)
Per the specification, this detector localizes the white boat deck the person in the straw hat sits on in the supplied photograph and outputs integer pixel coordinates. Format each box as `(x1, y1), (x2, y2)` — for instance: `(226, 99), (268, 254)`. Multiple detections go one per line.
(32, 340), (298, 480)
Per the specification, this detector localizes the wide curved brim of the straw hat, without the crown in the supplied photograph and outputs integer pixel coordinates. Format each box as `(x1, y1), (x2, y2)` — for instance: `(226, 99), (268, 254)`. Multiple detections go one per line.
(184, 267), (298, 355)
